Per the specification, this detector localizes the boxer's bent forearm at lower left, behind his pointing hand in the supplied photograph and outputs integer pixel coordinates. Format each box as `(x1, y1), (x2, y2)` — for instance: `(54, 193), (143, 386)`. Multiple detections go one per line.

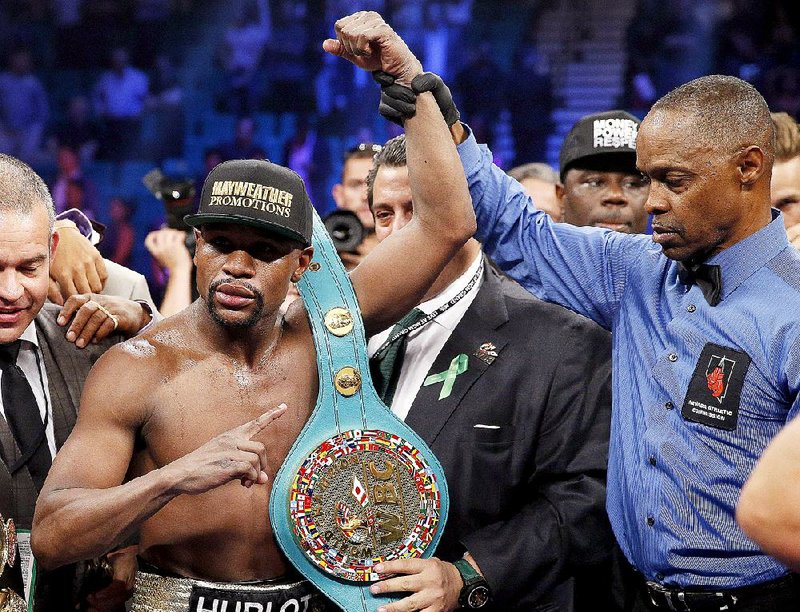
(31, 468), (180, 568)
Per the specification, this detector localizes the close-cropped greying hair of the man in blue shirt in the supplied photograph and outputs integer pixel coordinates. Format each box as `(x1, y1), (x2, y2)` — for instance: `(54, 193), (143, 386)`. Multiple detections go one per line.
(645, 74), (775, 168)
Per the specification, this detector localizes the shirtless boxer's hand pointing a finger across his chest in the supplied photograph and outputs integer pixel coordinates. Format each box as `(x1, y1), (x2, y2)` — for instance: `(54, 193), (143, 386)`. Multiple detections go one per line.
(162, 404), (287, 495)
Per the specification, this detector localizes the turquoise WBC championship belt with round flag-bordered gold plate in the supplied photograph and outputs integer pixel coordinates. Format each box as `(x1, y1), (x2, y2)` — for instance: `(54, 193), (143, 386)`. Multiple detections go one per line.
(270, 213), (449, 612)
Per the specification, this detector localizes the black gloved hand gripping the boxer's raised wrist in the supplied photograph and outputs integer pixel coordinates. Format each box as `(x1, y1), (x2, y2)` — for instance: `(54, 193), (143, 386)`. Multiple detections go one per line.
(372, 71), (461, 127)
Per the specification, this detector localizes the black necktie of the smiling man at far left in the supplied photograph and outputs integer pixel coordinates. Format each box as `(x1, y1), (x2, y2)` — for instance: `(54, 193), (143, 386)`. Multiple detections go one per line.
(0, 340), (52, 489)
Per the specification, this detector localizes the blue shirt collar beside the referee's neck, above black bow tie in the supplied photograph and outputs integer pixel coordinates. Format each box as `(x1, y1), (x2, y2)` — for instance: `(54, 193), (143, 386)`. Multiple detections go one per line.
(705, 209), (789, 300)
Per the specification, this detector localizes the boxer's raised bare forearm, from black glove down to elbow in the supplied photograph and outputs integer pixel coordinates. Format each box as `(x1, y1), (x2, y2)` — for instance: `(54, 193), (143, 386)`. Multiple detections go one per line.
(405, 93), (475, 248)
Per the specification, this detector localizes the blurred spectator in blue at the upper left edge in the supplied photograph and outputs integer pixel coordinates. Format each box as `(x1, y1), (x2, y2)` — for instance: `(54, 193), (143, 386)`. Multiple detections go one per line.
(0, 48), (49, 163)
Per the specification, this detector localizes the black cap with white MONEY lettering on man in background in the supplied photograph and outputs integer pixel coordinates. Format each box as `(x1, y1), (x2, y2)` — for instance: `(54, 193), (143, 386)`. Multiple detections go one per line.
(558, 110), (641, 182)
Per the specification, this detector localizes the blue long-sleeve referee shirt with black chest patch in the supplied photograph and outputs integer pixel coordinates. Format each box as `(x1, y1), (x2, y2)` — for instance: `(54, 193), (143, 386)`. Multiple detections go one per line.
(458, 129), (800, 588)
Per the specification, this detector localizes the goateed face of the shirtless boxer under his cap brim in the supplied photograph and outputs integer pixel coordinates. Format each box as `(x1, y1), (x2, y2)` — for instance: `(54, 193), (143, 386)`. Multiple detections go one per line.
(194, 223), (313, 328)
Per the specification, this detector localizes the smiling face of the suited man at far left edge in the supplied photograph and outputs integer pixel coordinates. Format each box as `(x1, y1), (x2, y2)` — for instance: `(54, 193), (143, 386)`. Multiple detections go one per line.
(0, 206), (58, 344)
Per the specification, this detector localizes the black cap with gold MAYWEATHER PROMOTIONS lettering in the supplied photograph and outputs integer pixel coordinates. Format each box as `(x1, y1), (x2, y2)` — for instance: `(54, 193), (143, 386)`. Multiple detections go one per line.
(184, 159), (313, 246)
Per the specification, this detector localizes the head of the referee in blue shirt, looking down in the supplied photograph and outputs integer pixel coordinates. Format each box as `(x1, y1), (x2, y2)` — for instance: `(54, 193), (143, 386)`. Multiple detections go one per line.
(636, 76), (775, 263)
